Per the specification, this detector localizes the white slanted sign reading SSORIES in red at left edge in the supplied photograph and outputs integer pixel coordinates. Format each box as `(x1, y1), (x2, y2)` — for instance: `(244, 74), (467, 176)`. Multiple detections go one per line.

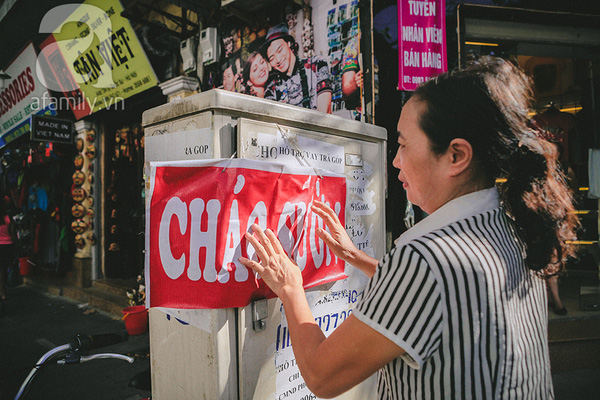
(0, 43), (55, 147)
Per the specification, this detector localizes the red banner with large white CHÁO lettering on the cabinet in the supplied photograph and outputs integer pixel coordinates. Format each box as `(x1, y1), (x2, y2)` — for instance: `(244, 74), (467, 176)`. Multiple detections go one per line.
(146, 159), (346, 308)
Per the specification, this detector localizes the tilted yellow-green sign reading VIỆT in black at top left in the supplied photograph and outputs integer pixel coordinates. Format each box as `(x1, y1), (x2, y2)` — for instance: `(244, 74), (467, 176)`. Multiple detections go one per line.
(40, 0), (157, 118)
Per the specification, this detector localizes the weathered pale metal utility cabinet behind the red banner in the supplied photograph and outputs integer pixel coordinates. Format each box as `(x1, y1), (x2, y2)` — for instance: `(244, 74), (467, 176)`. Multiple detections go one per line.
(142, 90), (387, 400)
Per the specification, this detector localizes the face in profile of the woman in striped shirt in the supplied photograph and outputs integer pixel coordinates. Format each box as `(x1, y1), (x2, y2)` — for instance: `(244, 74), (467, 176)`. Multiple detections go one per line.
(393, 98), (445, 214)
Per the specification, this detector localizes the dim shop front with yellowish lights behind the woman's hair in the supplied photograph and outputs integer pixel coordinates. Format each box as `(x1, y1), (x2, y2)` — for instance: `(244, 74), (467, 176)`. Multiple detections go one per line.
(458, 4), (600, 284)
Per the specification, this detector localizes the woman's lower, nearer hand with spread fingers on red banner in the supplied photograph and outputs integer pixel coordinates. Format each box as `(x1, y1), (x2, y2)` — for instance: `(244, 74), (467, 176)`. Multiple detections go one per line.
(239, 224), (303, 297)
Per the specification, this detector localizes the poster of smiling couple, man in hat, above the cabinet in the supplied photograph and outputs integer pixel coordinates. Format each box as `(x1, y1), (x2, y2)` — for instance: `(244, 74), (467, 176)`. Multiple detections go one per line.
(218, 0), (362, 120)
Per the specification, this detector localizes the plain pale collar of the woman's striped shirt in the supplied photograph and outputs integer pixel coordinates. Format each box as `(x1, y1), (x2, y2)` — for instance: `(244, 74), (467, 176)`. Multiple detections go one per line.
(395, 187), (500, 247)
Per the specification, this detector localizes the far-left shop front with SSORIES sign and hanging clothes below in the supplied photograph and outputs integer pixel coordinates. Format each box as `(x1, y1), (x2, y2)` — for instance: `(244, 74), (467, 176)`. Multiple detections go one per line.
(0, 43), (74, 284)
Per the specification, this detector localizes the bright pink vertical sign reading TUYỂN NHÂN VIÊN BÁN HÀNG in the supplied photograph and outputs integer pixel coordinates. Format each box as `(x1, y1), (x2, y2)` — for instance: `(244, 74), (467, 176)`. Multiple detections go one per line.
(398, 0), (448, 91)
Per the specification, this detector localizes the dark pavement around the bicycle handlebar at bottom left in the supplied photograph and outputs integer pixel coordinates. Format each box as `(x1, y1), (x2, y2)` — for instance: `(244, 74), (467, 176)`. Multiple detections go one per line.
(0, 286), (150, 400)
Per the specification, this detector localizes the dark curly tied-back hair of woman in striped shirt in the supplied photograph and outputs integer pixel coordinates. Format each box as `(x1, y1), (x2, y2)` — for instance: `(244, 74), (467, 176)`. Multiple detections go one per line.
(414, 56), (579, 276)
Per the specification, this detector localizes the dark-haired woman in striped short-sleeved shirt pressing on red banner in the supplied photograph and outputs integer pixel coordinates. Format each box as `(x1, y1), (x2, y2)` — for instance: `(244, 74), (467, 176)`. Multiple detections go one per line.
(240, 58), (576, 399)
